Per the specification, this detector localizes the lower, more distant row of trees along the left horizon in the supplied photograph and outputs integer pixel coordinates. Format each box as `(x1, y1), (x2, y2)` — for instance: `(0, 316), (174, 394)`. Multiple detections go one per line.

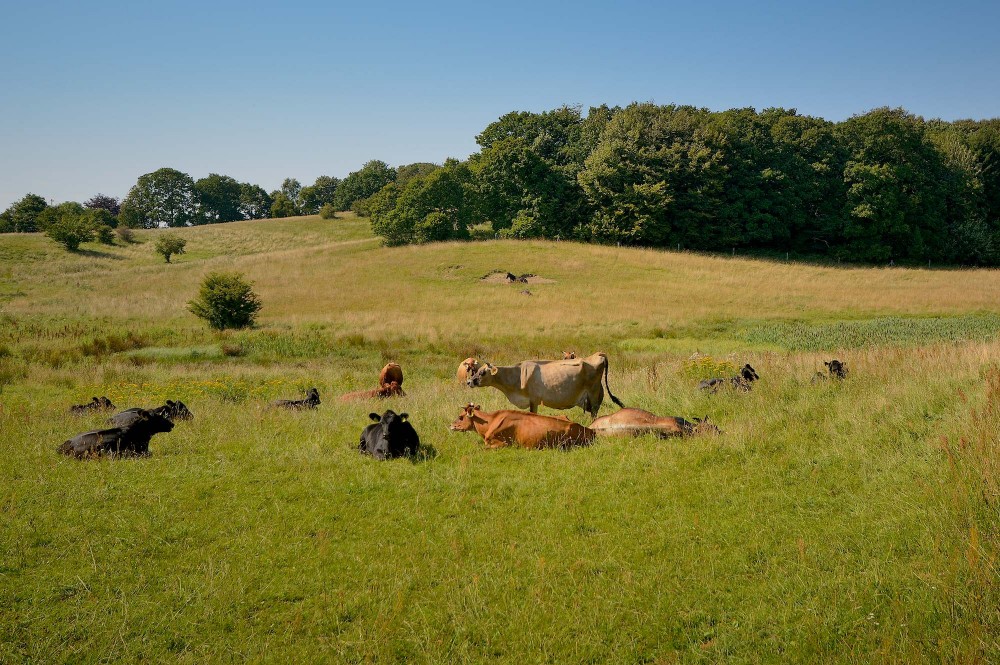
(0, 160), (398, 233)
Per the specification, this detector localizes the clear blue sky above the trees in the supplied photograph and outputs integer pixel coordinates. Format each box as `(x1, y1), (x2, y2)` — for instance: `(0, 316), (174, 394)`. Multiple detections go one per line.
(0, 0), (1000, 209)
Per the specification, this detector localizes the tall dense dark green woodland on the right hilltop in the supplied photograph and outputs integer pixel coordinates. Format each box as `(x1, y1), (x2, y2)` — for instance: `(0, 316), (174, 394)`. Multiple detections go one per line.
(362, 104), (1000, 265)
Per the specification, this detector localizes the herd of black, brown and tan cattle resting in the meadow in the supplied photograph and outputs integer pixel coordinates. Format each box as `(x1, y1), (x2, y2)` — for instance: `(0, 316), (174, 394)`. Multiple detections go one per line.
(58, 352), (847, 460)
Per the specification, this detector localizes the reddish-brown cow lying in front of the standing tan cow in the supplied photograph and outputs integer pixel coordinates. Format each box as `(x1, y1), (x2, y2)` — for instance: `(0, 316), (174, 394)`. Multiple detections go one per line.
(448, 404), (595, 449)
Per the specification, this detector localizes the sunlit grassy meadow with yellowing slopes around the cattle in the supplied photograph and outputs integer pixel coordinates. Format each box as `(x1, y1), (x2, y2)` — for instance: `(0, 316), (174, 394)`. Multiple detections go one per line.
(0, 217), (1000, 663)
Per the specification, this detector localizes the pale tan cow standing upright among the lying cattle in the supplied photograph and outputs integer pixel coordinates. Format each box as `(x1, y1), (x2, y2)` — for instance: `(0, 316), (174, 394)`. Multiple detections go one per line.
(468, 353), (625, 417)
